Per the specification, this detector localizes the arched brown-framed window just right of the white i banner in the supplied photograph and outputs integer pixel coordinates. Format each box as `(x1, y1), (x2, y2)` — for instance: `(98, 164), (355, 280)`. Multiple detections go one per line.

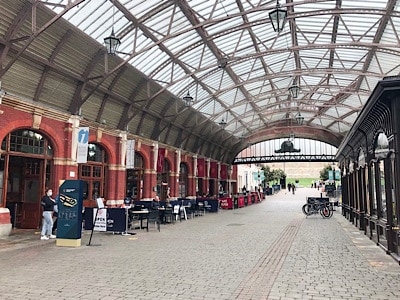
(79, 144), (107, 200)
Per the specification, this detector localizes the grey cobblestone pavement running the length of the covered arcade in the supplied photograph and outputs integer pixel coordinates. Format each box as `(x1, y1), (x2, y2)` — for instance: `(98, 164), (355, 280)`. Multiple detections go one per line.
(0, 188), (400, 300)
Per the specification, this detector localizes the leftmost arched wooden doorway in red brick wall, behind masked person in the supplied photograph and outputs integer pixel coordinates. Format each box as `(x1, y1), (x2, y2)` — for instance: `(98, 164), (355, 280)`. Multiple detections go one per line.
(0, 129), (53, 229)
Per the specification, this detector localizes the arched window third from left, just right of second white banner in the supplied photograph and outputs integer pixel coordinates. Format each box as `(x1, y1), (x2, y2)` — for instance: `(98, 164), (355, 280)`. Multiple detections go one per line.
(126, 152), (144, 200)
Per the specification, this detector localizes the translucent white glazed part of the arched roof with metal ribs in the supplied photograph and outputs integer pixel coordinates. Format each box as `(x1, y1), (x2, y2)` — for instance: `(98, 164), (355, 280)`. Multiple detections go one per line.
(42, 0), (400, 142)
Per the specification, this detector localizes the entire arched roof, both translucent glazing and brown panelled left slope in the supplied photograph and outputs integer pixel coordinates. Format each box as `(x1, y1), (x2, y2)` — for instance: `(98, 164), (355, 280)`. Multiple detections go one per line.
(0, 0), (400, 161)
